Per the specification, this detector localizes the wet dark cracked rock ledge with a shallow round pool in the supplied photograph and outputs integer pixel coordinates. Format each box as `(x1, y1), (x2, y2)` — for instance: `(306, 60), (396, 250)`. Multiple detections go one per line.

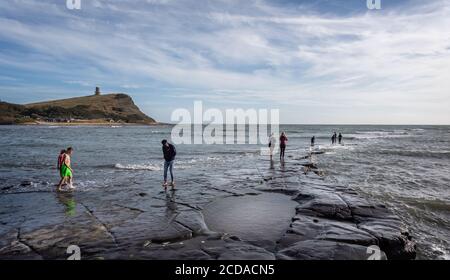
(0, 152), (416, 260)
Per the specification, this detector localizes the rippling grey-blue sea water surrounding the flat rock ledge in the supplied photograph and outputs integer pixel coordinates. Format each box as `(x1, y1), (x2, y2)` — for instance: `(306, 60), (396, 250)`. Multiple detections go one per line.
(0, 125), (450, 259)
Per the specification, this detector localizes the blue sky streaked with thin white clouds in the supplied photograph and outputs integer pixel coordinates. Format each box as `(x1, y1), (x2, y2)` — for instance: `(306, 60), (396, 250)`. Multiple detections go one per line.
(0, 0), (450, 124)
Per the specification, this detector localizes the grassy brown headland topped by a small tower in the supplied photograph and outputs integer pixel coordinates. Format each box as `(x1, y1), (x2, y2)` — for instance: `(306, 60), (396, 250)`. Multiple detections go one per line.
(0, 87), (158, 125)
